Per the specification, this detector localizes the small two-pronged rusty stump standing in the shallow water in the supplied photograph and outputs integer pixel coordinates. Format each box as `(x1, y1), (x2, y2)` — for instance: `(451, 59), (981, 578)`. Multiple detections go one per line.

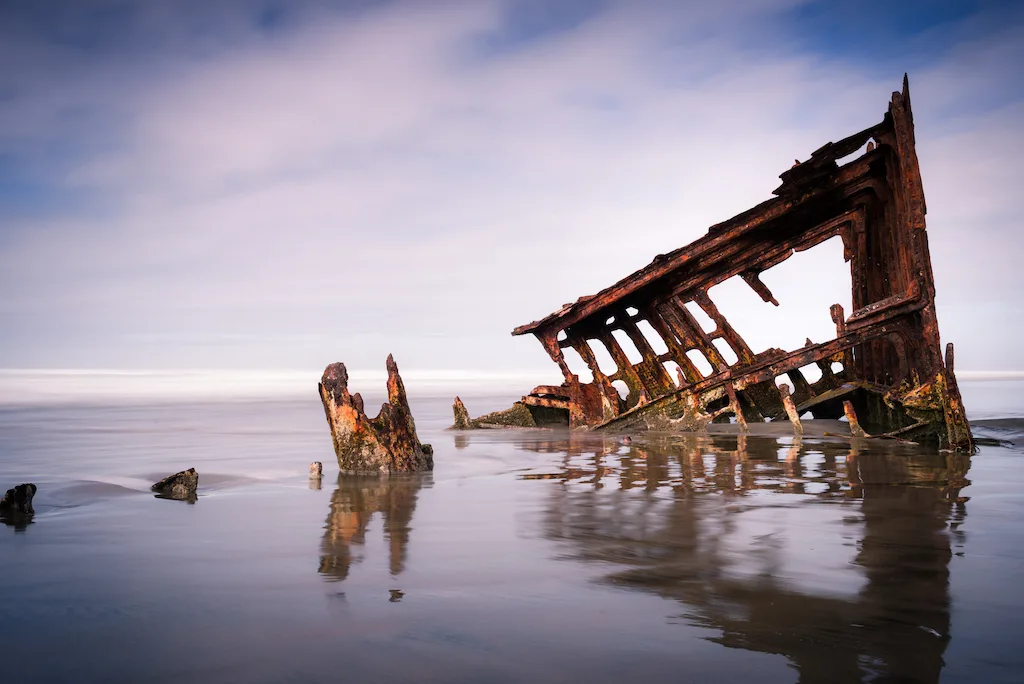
(319, 354), (434, 473)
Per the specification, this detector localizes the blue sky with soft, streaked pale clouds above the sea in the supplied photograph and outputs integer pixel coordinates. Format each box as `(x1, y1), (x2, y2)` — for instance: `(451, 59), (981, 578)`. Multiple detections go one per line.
(0, 0), (1024, 382)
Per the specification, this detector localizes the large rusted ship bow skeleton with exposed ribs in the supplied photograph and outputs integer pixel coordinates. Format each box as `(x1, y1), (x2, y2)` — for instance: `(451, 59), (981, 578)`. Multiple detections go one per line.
(512, 77), (973, 451)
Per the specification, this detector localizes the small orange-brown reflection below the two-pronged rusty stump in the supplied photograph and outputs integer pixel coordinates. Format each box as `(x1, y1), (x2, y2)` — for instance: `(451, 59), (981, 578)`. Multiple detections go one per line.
(318, 473), (430, 581)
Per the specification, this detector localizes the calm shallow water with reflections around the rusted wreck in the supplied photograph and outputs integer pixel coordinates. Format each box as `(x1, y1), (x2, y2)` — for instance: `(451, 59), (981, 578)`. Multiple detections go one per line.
(0, 383), (1024, 682)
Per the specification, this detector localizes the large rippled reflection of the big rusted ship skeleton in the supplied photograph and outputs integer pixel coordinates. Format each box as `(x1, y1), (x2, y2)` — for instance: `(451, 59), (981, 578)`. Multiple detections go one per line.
(522, 435), (970, 682)
